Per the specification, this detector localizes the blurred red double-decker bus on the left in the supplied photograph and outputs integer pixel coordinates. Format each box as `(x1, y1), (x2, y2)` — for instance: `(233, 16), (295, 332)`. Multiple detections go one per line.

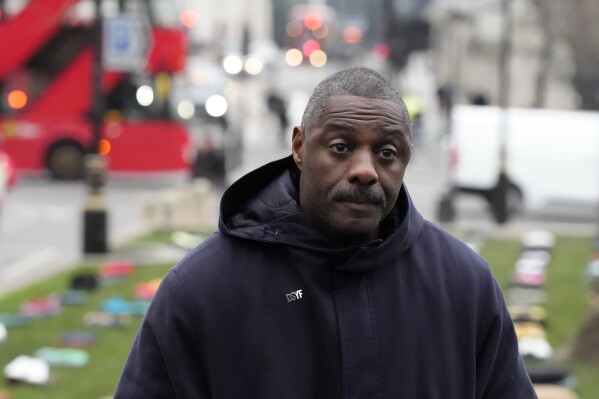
(0, 0), (193, 179)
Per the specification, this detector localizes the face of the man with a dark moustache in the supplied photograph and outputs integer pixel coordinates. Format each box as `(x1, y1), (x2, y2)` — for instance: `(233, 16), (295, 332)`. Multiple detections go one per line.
(292, 95), (411, 245)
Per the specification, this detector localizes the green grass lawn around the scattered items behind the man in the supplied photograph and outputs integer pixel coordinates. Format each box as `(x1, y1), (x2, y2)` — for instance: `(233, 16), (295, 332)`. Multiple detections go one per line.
(0, 234), (599, 399)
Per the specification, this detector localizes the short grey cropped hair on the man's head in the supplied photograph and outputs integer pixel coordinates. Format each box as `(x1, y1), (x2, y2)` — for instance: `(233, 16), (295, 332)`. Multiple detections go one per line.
(301, 67), (412, 136)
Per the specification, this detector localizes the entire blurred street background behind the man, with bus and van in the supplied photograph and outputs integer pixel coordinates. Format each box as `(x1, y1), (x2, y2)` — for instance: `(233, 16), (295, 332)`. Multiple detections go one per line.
(0, 0), (599, 399)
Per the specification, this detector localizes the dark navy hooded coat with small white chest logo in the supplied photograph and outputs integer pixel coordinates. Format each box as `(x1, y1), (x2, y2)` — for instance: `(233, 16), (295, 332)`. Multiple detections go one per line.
(115, 157), (536, 399)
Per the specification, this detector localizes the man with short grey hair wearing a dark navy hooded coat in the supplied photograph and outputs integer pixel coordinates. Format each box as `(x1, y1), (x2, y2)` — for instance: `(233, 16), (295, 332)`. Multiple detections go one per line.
(115, 68), (536, 399)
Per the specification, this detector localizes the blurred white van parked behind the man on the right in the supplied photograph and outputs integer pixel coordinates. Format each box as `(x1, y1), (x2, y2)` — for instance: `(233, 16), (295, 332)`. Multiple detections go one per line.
(442, 105), (599, 221)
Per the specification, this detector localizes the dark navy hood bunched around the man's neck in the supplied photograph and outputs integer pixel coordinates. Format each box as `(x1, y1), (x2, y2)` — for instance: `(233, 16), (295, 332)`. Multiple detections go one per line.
(219, 156), (424, 273)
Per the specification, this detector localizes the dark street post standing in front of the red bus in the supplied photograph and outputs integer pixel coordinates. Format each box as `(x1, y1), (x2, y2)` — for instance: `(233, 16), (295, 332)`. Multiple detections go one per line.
(83, 0), (108, 254)
